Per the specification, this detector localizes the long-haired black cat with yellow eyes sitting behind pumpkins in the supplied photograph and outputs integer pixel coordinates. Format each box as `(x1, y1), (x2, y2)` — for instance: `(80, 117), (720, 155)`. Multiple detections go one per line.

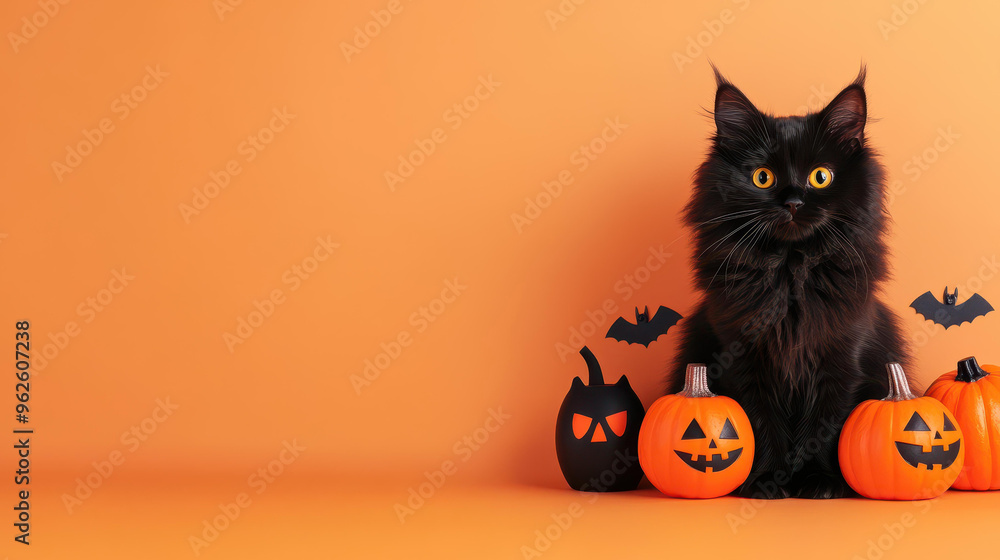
(668, 68), (906, 498)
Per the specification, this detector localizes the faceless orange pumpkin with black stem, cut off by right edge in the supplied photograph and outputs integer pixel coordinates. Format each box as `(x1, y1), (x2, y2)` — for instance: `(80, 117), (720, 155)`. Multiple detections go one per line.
(925, 356), (1000, 490)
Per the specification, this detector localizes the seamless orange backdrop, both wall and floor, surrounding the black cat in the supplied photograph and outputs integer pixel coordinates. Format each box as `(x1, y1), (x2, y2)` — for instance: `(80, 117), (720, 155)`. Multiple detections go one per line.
(0, 0), (1000, 558)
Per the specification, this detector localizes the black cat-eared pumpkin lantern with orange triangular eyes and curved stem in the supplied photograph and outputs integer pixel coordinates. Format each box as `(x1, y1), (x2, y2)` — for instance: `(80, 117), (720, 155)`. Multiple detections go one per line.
(556, 346), (646, 492)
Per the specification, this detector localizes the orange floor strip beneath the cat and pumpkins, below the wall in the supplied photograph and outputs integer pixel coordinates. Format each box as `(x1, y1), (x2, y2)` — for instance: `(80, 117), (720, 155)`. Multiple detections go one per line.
(10, 467), (1000, 560)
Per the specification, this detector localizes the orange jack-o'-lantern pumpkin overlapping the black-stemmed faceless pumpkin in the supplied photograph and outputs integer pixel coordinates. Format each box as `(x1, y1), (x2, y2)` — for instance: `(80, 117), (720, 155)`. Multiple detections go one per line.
(838, 362), (965, 500)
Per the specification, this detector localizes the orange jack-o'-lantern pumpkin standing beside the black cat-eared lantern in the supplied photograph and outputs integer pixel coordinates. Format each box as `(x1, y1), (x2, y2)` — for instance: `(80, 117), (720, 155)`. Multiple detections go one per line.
(639, 364), (754, 498)
